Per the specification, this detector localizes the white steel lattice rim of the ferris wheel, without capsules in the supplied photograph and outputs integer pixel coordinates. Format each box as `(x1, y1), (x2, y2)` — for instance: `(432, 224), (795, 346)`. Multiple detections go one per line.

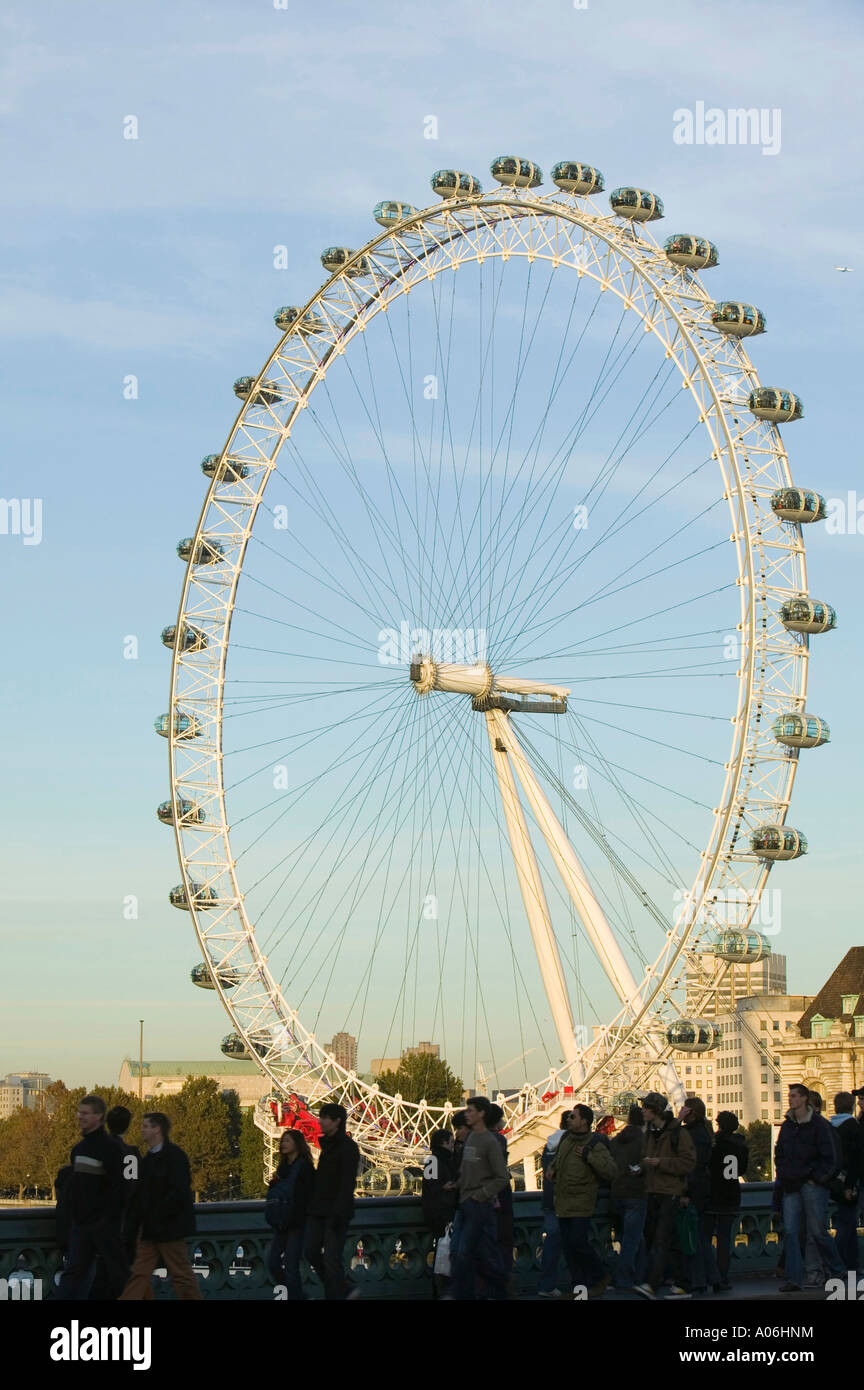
(171, 179), (808, 1166)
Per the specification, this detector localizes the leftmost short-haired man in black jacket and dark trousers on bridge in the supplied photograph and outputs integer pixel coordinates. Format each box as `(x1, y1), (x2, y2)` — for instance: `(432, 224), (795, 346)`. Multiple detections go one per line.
(57, 1095), (129, 1300)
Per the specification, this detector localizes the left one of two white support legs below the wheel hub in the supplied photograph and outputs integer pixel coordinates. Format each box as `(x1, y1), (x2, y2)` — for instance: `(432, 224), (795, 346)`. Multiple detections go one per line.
(485, 709), (583, 1086)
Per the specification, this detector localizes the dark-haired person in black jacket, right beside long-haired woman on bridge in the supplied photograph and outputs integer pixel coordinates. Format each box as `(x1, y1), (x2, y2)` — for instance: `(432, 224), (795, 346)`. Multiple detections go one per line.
(306, 1104), (360, 1298)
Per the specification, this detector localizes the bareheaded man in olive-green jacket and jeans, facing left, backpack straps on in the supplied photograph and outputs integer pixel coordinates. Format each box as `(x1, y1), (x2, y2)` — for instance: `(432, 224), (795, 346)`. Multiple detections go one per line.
(547, 1105), (618, 1298)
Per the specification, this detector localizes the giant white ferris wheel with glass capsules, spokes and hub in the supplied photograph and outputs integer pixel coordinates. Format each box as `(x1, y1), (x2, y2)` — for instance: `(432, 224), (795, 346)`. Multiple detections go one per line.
(156, 157), (835, 1166)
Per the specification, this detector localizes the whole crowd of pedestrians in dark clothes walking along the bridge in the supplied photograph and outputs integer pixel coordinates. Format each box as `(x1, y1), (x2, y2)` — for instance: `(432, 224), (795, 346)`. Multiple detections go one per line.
(53, 1086), (864, 1301)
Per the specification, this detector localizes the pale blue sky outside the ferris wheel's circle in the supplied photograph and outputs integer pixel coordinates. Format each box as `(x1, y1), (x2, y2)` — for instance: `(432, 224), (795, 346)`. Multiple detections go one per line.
(0, 0), (864, 1084)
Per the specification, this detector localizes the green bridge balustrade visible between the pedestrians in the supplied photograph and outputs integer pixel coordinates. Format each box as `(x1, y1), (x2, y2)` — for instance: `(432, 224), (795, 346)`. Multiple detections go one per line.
(0, 1183), (782, 1300)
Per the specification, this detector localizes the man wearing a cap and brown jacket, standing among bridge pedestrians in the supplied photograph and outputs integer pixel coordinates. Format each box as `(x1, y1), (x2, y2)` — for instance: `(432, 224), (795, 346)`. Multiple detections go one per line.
(633, 1091), (696, 1298)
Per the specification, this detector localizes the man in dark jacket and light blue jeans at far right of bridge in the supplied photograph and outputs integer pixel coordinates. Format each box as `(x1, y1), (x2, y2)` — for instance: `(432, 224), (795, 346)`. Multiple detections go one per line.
(774, 1086), (846, 1294)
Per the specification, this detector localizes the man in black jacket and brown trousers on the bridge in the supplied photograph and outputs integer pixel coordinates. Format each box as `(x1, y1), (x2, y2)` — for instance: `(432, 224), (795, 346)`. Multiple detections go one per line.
(119, 1111), (201, 1302)
